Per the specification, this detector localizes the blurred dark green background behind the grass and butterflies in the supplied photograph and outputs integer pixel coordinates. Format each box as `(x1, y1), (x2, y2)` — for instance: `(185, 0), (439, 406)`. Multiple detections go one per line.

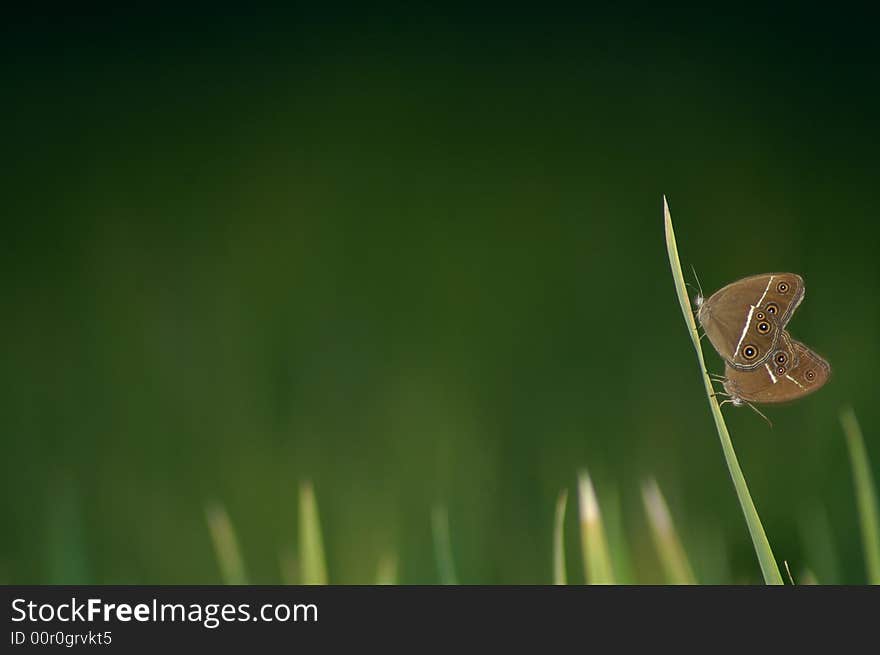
(0, 8), (880, 584)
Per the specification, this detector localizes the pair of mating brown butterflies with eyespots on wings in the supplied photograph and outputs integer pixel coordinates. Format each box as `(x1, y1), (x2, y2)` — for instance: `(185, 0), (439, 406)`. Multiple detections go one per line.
(696, 273), (831, 405)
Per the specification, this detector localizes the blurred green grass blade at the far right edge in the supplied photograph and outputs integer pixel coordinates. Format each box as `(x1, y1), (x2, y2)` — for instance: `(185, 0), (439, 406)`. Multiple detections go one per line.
(840, 408), (880, 584)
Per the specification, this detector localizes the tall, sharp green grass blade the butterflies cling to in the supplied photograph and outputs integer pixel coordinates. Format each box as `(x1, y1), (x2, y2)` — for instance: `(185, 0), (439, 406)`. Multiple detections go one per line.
(663, 196), (784, 585)
